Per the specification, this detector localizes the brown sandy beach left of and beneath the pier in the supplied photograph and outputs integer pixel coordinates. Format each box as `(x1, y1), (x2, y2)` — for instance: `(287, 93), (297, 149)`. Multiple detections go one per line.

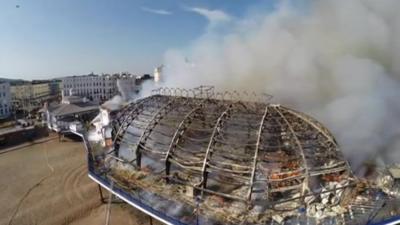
(0, 138), (160, 225)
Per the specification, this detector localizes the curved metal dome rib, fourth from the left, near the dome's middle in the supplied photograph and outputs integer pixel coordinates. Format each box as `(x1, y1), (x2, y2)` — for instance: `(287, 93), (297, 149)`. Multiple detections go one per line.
(200, 104), (233, 197)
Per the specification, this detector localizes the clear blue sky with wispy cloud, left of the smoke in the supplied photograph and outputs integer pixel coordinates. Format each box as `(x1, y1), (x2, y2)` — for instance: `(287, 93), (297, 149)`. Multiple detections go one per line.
(0, 0), (282, 79)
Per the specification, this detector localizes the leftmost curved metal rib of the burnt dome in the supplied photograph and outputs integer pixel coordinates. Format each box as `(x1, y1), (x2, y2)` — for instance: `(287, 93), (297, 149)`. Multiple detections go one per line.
(113, 97), (158, 151)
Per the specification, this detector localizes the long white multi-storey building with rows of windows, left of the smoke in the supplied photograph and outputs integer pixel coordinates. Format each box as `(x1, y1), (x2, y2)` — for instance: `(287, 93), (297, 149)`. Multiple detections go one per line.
(61, 73), (136, 102)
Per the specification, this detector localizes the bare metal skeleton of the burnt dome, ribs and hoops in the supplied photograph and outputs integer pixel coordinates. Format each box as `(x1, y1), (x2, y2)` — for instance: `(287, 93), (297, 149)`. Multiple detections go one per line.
(110, 88), (351, 207)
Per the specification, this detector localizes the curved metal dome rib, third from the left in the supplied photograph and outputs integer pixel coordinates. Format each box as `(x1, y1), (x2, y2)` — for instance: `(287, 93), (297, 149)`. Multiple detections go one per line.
(165, 102), (207, 181)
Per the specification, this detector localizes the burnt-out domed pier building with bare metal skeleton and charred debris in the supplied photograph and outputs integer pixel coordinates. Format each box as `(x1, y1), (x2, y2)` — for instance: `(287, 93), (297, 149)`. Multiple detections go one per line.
(88, 86), (362, 224)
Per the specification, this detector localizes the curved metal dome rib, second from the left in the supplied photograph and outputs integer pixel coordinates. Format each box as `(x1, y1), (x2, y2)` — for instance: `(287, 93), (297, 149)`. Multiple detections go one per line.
(134, 97), (190, 169)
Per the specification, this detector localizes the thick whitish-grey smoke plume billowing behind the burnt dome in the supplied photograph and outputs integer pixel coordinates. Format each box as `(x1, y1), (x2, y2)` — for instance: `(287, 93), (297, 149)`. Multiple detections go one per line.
(159, 0), (400, 167)
